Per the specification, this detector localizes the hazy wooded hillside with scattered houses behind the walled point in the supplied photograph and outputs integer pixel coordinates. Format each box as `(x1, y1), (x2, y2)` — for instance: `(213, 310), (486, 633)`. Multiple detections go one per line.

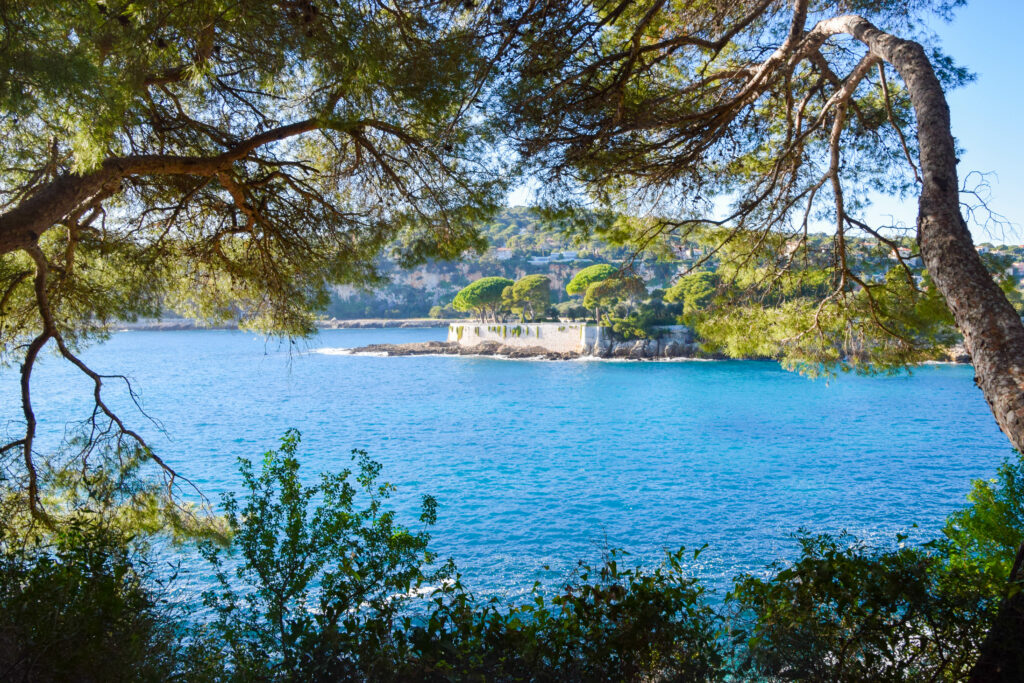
(325, 207), (1024, 331)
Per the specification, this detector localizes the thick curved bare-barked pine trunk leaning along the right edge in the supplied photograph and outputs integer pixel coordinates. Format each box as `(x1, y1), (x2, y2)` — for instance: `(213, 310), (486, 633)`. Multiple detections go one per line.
(827, 16), (1024, 683)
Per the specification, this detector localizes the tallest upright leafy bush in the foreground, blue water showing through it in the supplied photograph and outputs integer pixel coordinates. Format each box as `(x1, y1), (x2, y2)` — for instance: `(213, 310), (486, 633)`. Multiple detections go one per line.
(201, 431), (451, 681)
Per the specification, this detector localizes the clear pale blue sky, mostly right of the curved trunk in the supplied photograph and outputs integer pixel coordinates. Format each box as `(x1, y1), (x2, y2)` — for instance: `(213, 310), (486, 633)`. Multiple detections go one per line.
(509, 0), (1024, 244)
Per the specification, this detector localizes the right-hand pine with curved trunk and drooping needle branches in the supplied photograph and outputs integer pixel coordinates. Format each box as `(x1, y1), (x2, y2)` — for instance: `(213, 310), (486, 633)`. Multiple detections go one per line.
(503, 0), (1024, 458)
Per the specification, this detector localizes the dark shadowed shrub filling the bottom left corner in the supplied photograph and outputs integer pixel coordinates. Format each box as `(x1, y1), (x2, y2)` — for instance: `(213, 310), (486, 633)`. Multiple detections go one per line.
(0, 519), (181, 681)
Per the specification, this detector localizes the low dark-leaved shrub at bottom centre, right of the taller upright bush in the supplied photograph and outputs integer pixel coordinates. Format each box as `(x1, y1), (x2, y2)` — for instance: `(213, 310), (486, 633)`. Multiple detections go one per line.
(403, 550), (725, 682)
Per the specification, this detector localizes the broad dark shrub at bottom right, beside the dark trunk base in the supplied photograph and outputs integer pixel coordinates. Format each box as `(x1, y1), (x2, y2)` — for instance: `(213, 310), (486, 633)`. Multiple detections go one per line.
(731, 533), (999, 682)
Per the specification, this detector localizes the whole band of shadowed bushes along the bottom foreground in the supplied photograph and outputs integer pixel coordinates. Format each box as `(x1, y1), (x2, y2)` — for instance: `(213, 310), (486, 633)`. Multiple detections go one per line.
(0, 432), (1024, 681)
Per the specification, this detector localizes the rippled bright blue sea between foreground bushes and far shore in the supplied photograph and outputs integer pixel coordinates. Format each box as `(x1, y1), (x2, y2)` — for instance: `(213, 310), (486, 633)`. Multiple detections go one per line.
(0, 330), (1011, 593)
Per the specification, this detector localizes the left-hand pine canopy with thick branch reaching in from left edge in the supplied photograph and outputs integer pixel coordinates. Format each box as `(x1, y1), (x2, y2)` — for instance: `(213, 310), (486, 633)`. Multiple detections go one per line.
(0, 0), (502, 509)
